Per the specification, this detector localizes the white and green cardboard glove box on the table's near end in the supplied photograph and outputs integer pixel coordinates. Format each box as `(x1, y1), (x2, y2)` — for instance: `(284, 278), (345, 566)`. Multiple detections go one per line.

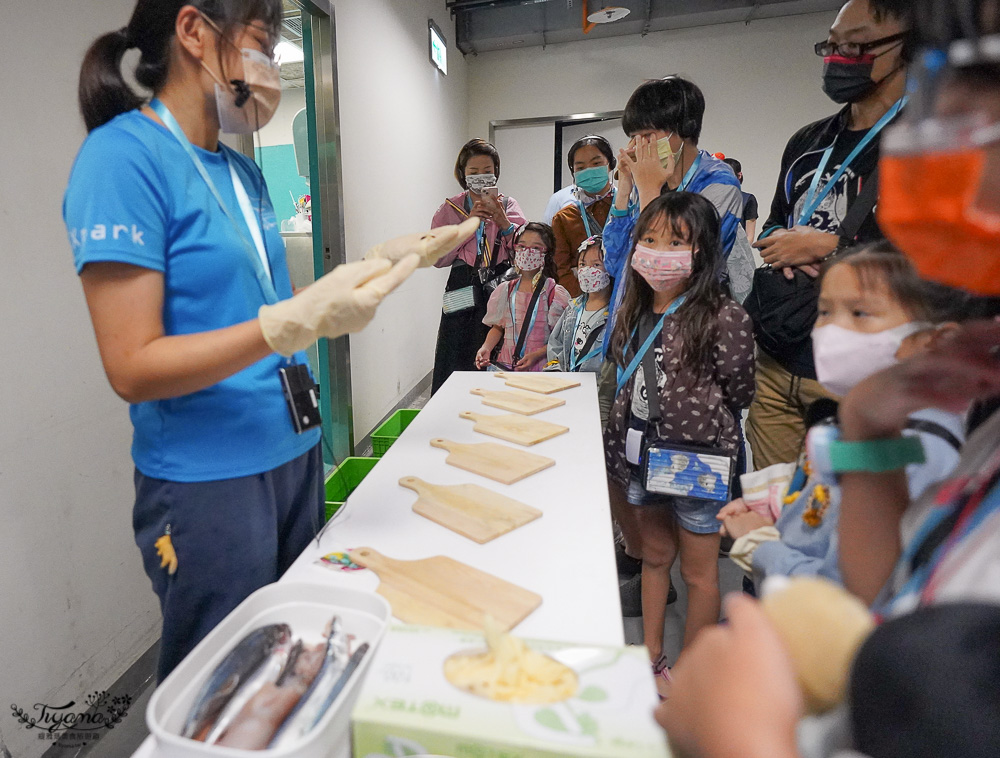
(351, 625), (669, 758)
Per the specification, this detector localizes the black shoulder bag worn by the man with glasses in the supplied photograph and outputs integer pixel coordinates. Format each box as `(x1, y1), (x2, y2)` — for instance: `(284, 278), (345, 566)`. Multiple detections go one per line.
(743, 168), (878, 362)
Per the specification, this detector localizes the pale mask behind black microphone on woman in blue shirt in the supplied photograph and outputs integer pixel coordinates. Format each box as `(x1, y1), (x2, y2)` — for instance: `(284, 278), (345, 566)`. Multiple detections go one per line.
(201, 48), (281, 134)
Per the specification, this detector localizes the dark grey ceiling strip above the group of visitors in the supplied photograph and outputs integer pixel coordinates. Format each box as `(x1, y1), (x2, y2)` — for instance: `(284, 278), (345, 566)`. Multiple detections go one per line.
(447, 0), (845, 55)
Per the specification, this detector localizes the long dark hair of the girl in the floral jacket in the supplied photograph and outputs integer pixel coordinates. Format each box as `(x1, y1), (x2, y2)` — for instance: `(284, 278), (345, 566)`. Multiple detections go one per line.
(610, 192), (726, 375)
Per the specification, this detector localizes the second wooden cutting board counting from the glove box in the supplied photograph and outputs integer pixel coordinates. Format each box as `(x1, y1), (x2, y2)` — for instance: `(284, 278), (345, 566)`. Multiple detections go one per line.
(399, 476), (542, 545)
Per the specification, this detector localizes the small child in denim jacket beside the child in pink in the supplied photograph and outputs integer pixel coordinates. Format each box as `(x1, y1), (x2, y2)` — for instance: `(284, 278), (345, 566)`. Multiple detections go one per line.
(545, 236), (611, 373)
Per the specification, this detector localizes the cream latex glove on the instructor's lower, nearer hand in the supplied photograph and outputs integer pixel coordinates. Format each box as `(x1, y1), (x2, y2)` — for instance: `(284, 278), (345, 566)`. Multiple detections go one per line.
(257, 255), (420, 355)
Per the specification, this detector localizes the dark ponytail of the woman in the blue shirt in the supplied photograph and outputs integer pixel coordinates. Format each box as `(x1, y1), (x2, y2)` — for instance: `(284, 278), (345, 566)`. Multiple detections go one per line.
(79, 27), (144, 132)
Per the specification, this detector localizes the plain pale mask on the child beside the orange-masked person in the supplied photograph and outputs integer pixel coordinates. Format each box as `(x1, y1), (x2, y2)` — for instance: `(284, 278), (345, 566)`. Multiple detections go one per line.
(812, 321), (928, 397)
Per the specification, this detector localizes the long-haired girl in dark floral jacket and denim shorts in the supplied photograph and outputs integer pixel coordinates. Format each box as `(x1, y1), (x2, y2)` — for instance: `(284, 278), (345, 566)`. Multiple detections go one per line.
(602, 192), (754, 686)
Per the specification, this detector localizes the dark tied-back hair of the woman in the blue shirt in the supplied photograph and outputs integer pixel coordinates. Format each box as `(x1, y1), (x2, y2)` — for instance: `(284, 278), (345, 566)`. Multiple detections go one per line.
(79, 0), (282, 132)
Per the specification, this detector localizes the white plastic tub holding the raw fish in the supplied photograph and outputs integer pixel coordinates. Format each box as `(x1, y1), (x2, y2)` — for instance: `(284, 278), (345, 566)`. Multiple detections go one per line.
(146, 582), (392, 758)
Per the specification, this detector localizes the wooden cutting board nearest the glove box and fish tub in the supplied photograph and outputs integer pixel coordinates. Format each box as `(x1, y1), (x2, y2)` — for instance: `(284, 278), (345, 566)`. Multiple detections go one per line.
(348, 547), (542, 631)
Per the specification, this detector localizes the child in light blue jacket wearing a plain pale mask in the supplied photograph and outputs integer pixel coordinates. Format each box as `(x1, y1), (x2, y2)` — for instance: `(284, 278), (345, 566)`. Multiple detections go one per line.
(718, 248), (973, 586)
